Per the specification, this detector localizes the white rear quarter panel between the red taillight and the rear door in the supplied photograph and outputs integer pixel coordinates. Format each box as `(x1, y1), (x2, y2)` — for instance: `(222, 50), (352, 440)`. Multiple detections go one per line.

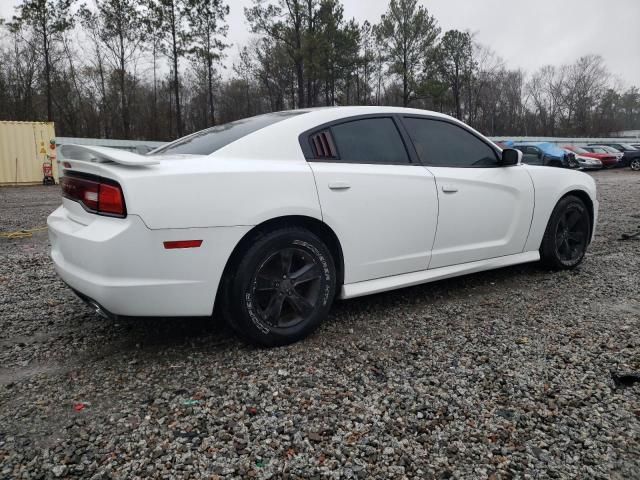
(108, 157), (322, 229)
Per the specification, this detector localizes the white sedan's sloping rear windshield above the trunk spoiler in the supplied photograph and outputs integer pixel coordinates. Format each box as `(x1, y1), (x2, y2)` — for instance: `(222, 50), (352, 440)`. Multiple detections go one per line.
(150, 111), (306, 155)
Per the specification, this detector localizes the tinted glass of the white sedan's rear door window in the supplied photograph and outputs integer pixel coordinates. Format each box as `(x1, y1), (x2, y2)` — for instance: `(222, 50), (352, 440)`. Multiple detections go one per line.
(310, 117), (410, 164)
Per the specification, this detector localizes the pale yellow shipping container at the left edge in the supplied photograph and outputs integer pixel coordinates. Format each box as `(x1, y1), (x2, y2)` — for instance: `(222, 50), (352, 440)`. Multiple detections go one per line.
(0, 121), (58, 186)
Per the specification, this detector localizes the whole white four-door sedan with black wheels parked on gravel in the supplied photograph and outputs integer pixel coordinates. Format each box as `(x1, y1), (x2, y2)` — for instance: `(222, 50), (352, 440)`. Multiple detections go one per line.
(48, 107), (598, 346)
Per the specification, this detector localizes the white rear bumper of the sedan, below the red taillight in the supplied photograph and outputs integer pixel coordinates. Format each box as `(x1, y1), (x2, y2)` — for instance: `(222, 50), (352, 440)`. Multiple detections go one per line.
(47, 202), (249, 317)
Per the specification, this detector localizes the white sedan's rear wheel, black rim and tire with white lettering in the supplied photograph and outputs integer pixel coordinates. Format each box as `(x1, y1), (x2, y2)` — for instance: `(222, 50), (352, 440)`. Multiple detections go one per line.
(221, 227), (336, 347)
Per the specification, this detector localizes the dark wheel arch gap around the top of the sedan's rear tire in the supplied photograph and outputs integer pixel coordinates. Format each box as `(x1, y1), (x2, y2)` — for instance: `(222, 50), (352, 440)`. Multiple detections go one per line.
(214, 215), (344, 311)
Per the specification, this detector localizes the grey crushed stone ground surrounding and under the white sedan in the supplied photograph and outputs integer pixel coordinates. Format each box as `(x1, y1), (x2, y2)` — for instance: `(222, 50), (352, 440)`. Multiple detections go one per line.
(0, 169), (640, 479)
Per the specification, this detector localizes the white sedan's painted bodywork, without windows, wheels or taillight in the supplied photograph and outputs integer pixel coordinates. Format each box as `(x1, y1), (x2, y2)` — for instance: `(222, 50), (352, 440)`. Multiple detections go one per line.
(48, 107), (598, 316)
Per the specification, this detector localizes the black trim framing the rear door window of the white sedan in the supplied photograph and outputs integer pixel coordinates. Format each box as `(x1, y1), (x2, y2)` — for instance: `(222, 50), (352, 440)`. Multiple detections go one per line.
(298, 113), (423, 166)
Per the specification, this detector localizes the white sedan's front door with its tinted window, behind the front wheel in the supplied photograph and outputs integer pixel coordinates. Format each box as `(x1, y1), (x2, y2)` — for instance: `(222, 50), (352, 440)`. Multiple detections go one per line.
(403, 117), (534, 268)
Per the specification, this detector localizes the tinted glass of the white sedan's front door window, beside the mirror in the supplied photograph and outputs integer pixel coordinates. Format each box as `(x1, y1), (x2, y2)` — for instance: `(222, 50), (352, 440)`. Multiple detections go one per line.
(404, 118), (498, 167)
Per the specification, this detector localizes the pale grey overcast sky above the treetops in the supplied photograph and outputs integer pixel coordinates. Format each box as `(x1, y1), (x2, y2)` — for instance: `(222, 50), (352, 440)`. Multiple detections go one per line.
(0, 0), (640, 86)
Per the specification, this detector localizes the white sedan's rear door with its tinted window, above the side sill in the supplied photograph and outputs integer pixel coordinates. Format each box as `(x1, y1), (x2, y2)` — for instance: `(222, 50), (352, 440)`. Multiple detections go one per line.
(301, 115), (438, 283)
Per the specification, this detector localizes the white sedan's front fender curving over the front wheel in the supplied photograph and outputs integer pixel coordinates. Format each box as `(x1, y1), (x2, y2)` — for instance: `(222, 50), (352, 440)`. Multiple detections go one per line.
(525, 165), (598, 251)
